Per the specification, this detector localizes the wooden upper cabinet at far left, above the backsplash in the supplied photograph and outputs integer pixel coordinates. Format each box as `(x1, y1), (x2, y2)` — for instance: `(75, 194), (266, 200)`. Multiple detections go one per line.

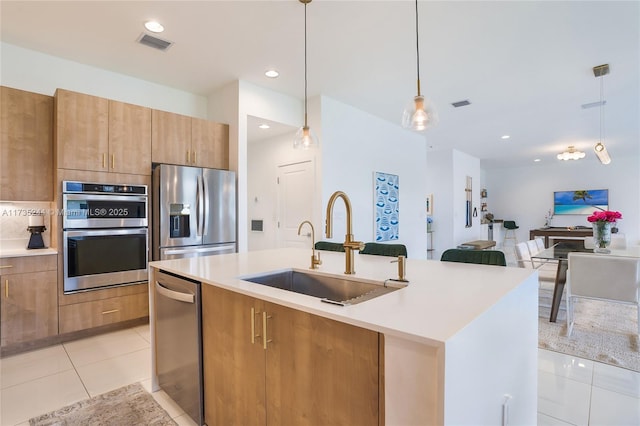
(0, 87), (53, 201)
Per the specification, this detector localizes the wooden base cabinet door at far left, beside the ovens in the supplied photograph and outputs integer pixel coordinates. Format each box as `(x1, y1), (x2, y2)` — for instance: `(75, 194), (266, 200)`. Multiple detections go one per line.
(0, 271), (58, 346)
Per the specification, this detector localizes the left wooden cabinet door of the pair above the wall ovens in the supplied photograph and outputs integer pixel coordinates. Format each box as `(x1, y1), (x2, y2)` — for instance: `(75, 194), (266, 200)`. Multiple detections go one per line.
(55, 89), (109, 171)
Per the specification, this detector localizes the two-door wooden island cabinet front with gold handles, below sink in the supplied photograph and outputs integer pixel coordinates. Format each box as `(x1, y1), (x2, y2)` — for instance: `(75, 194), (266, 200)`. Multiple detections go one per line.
(202, 285), (383, 426)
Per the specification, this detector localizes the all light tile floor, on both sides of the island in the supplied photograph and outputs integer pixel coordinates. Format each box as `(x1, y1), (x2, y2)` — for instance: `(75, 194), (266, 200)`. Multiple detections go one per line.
(0, 325), (640, 426)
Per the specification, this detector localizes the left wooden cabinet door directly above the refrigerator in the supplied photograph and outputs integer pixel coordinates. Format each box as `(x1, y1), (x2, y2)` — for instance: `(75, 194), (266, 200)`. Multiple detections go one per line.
(151, 109), (191, 166)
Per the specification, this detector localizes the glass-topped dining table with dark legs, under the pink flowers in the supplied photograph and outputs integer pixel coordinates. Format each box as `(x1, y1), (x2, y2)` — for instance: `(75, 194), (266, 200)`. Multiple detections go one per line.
(531, 243), (640, 322)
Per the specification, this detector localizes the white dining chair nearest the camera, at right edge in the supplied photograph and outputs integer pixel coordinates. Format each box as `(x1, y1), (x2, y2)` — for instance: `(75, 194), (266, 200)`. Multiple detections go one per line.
(565, 252), (640, 337)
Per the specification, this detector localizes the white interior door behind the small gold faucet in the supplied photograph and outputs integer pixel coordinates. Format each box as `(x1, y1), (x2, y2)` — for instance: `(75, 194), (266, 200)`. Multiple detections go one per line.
(277, 161), (322, 248)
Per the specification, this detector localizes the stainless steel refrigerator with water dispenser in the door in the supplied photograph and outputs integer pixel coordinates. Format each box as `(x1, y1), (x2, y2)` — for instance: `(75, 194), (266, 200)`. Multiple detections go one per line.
(152, 164), (237, 260)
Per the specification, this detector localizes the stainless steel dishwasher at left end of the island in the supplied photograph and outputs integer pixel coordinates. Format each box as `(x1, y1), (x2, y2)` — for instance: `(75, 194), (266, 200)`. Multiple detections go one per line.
(155, 270), (204, 425)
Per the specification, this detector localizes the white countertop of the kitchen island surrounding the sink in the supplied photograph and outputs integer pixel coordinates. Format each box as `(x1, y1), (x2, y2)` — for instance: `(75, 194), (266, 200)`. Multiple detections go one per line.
(150, 249), (537, 346)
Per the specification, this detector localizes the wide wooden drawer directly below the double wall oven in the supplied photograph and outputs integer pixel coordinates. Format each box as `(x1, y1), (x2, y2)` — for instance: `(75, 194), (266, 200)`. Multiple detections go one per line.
(59, 293), (149, 334)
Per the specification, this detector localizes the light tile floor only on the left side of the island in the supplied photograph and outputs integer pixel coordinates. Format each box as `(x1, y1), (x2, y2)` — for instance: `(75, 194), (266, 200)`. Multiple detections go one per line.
(0, 325), (195, 426)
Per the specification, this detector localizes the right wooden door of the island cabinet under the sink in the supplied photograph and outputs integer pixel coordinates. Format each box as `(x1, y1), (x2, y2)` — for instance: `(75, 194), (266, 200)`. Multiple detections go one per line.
(265, 303), (379, 426)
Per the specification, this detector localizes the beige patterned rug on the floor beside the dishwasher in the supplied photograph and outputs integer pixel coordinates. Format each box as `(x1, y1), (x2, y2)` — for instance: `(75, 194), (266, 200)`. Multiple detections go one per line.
(29, 383), (177, 426)
